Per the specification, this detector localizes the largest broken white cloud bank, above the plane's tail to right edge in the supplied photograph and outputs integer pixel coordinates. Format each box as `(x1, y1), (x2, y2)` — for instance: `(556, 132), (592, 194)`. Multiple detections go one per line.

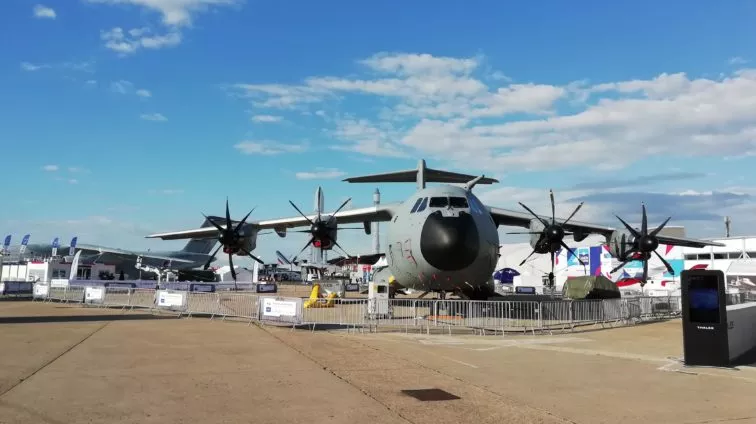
(224, 54), (756, 172)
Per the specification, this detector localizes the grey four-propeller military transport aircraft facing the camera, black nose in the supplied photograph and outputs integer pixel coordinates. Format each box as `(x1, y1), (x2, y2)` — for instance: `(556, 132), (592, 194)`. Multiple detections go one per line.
(147, 159), (721, 300)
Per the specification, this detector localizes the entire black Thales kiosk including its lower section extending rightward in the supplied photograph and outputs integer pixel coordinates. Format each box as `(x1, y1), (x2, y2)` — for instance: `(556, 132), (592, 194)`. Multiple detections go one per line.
(681, 270), (756, 367)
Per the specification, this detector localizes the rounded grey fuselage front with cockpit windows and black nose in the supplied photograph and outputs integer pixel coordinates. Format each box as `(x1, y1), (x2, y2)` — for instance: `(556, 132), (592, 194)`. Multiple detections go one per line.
(386, 185), (499, 298)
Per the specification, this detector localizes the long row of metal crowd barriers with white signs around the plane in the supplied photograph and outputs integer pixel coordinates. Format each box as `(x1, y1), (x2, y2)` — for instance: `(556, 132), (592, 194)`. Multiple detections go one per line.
(26, 283), (681, 334)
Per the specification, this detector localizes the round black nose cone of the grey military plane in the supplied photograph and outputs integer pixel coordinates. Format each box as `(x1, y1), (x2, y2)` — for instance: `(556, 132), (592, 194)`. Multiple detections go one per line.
(420, 212), (480, 271)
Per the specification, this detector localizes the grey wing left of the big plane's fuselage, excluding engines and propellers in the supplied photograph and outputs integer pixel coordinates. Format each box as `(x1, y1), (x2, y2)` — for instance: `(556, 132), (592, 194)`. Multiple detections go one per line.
(147, 203), (401, 240)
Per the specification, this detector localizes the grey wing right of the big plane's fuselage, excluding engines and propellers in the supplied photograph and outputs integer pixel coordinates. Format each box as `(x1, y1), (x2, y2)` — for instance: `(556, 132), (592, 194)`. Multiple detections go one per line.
(488, 206), (724, 247)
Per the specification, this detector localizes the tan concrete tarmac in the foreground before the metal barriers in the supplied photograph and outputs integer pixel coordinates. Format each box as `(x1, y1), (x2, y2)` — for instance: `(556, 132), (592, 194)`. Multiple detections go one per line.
(0, 301), (756, 424)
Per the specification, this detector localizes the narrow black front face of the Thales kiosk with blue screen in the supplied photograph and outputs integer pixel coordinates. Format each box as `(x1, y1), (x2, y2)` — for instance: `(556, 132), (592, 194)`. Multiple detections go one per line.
(680, 270), (730, 367)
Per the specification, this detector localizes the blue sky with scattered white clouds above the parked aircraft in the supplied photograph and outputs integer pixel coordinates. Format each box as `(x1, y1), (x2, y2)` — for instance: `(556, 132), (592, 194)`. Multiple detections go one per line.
(0, 0), (756, 262)
